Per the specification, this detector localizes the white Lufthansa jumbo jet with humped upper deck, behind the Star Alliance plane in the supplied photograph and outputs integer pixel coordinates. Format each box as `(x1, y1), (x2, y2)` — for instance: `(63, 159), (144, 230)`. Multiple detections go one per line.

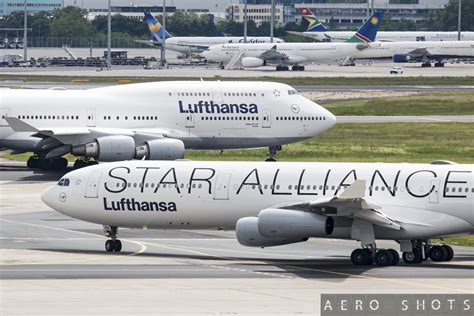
(0, 81), (336, 169)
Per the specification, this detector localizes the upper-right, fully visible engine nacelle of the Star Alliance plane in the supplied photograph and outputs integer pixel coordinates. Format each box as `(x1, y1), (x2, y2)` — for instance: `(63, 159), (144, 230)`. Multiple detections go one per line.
(258, 209), (334, 239)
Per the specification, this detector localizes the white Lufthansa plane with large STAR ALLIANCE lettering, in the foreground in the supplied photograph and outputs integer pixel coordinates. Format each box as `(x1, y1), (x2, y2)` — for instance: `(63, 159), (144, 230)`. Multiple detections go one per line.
(41, 161), (474, 266)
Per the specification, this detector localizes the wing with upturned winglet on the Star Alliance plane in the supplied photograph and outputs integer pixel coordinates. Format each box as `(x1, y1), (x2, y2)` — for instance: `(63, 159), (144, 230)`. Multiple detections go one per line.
(278, 180), (402, 230)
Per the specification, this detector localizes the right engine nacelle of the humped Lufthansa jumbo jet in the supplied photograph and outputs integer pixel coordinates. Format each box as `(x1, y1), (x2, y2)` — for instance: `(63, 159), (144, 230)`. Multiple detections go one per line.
(135, 138), (185, 160)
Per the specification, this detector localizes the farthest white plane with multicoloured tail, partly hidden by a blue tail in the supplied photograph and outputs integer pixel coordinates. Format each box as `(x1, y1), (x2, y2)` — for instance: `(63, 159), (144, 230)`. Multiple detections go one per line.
(288, 7), (474, 42)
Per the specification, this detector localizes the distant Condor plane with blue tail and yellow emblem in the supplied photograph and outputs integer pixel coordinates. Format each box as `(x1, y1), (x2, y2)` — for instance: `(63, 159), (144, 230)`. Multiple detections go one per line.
(137, 12), (285, 54)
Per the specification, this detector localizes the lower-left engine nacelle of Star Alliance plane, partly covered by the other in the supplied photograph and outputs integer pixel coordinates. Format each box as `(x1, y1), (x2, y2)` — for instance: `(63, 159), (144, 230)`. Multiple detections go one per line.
(235, 217), (308, 247)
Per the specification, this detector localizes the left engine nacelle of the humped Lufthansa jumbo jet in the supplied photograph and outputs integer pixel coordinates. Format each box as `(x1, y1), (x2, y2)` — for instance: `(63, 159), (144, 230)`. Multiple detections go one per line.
(71, 135), (135, 161)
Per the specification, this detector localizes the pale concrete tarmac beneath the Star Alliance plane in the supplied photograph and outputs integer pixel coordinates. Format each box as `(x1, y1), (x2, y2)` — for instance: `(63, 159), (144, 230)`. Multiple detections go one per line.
(0, 160), (474, 315)
